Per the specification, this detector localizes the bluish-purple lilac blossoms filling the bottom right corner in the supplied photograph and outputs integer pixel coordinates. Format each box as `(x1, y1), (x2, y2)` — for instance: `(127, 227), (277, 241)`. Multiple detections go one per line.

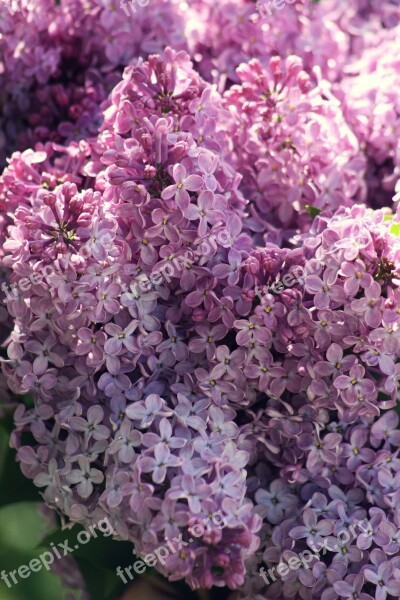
(245, 411), (400, 600)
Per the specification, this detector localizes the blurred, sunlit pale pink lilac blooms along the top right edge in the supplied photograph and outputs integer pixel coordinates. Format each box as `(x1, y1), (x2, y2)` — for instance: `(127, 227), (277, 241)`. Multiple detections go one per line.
(177, 0), (400, 90)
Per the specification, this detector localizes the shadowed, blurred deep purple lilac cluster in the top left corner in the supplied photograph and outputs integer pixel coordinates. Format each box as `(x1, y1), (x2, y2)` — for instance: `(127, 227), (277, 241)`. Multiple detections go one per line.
(0, 0), (186, 162)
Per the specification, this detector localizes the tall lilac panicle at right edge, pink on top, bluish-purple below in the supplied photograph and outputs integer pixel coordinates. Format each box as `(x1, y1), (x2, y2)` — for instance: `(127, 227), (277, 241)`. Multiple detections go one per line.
(235, 206), (400, 600)
